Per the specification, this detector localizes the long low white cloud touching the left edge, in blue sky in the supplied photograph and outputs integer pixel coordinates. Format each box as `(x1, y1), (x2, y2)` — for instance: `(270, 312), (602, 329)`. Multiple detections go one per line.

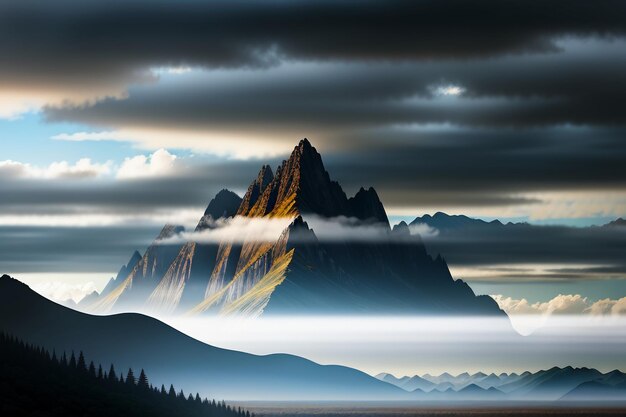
(0, 158), (112, 179)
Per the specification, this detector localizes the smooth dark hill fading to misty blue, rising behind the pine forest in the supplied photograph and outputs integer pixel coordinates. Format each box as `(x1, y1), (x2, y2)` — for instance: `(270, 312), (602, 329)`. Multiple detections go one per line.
(0, 275), (407, 400)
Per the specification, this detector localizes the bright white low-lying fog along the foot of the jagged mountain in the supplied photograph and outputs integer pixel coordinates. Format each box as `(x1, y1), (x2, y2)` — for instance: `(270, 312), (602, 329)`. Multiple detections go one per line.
(164, 316), (626, 376)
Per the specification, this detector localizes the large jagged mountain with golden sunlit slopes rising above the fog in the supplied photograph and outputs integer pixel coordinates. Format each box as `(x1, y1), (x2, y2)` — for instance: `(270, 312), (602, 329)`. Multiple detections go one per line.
(84, 139), (504, 316)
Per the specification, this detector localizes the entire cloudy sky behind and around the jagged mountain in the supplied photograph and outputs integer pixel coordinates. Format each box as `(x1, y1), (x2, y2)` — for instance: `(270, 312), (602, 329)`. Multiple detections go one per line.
(0, 0), (626, 312)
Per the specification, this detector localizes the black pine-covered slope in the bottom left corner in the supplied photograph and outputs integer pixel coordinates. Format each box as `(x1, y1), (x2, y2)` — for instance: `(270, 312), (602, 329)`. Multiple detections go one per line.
(0, 333), (251, 417)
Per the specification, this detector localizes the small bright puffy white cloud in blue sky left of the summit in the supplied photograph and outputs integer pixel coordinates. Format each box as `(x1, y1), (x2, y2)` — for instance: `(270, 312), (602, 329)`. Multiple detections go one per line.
(116, 149), (182, 179)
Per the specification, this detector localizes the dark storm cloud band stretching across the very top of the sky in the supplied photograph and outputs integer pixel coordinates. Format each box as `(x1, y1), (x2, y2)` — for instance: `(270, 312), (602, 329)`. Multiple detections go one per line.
(0, 0), (626, 82)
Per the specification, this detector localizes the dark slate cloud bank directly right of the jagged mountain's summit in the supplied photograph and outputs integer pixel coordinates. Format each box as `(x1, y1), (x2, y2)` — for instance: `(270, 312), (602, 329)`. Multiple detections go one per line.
(325, 128), (626, 208)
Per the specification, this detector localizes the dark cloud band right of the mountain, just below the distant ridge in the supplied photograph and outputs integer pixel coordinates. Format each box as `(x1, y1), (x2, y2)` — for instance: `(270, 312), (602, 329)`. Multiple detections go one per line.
(412, 221), (626, 282)
